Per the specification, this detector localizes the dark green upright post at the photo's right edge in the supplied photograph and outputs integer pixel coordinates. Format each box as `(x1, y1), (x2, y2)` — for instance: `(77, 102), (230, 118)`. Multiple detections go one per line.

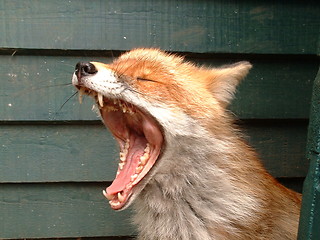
(298, 68), (320, 240)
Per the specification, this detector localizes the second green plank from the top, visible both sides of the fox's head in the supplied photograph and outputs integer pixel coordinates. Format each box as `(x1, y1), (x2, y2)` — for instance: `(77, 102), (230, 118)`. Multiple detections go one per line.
(0, 55), (318, 121)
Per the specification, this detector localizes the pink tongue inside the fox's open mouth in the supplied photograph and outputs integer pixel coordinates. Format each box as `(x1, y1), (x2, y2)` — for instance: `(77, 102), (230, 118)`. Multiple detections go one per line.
(107, 137), (147, 195)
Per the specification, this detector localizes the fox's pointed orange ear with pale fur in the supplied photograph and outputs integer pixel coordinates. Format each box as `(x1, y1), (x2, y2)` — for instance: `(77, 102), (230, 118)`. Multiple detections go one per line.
(210, 62), (252, 106)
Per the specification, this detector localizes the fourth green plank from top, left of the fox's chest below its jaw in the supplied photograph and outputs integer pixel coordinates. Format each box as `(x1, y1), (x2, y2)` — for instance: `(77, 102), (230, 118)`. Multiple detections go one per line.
(0, 183), (134, 239)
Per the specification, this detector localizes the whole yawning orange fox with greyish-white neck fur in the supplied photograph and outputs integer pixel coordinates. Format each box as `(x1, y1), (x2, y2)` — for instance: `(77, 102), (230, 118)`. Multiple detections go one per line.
(72, 48), (301, 240)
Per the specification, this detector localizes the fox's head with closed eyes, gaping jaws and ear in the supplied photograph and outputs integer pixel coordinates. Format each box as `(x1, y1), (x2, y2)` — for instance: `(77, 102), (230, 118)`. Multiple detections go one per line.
(72, 49), (251, 210)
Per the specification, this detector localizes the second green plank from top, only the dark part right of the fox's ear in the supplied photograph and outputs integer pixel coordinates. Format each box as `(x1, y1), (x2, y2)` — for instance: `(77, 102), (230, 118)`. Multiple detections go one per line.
(204, 56), (319, 119)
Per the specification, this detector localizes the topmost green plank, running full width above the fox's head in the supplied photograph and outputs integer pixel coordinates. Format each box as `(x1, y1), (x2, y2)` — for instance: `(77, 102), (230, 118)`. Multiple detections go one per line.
(0, 0), (320, 54)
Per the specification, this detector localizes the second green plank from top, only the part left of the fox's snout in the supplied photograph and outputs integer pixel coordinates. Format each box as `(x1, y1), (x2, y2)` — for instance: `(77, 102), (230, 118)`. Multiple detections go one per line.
(0, 56), (110, 121)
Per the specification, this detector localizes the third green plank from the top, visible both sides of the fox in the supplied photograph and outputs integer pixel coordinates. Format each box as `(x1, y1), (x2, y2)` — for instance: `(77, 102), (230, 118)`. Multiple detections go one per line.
(0, 121), (308, 182)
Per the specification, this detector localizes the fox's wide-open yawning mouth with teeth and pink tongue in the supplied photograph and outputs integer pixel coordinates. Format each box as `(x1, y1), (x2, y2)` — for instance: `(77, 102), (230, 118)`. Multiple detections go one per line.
(78, 87), (163, 210)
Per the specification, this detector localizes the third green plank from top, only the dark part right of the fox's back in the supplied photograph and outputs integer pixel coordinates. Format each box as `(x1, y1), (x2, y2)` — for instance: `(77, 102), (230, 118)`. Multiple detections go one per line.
(245, 120), (309, 177)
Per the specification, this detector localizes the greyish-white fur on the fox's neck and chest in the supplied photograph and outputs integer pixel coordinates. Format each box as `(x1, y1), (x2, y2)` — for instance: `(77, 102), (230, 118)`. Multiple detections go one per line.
(134, 115), (258, 240)
